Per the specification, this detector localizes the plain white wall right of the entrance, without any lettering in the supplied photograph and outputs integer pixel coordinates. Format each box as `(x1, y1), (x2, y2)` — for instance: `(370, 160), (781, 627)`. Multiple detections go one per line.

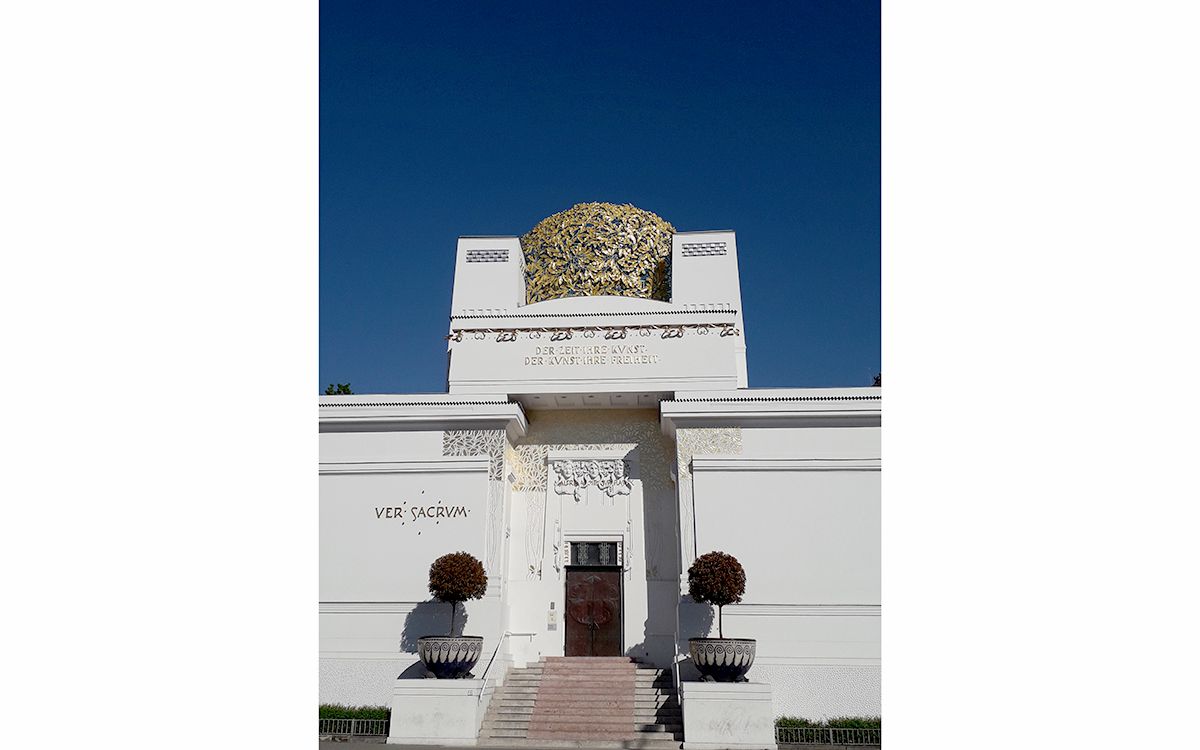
(680, 419), (881, 719)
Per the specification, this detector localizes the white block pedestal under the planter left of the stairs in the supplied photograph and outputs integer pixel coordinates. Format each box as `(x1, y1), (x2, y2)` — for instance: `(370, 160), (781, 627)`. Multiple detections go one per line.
(388, 679), (484, 745)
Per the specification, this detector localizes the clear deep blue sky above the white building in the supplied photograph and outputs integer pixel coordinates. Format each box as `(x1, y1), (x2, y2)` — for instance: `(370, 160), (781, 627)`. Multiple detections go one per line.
(319, 0), (881, 394)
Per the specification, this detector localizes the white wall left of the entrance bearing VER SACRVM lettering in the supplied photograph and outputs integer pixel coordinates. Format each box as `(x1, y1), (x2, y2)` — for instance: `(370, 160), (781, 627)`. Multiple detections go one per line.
(319, 426), (503, 706)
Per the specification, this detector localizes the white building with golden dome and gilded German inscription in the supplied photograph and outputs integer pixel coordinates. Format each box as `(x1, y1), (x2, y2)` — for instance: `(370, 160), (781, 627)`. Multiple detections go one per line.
(319, 204), (881, 719)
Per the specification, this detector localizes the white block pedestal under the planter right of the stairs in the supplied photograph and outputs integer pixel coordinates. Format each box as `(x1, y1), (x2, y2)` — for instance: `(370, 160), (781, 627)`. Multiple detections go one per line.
(679, 683), (776, 750)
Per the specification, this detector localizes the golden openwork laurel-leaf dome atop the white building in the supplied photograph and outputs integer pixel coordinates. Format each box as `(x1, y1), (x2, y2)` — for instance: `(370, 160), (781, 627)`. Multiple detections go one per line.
(521, 203), (676, 304)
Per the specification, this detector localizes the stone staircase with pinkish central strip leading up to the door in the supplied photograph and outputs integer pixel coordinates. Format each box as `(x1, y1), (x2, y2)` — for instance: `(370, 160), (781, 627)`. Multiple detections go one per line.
(479, 656), (683, 750)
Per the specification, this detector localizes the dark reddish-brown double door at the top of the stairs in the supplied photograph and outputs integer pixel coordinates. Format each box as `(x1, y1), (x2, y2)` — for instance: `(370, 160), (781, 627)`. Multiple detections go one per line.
(563, 566), (622, 656)
